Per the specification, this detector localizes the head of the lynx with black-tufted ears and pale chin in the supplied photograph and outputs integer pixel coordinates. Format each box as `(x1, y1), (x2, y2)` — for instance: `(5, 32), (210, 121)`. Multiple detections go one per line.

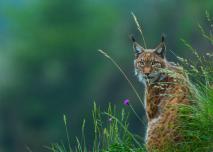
(132, 37), (166, 82)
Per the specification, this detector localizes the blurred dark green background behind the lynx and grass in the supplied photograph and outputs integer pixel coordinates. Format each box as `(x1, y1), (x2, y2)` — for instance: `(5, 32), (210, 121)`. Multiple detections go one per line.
(0, 0), (213, 152)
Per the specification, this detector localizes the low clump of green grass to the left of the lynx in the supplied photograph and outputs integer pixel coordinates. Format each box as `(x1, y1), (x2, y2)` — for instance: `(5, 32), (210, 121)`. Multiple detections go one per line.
(46, 103), (145, 152)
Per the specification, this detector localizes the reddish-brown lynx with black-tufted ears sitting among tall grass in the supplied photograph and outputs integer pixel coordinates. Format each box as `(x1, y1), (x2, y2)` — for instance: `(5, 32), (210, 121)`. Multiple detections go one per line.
(132, 37), (190, 151)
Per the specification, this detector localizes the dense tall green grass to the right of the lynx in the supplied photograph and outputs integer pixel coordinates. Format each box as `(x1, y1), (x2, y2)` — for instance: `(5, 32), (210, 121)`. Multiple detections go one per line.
(164, 12), (213, 152)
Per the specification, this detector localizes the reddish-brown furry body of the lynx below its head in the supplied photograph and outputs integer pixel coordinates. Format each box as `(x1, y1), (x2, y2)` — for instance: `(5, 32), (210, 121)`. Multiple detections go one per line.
(146, 71), (189, 151)
